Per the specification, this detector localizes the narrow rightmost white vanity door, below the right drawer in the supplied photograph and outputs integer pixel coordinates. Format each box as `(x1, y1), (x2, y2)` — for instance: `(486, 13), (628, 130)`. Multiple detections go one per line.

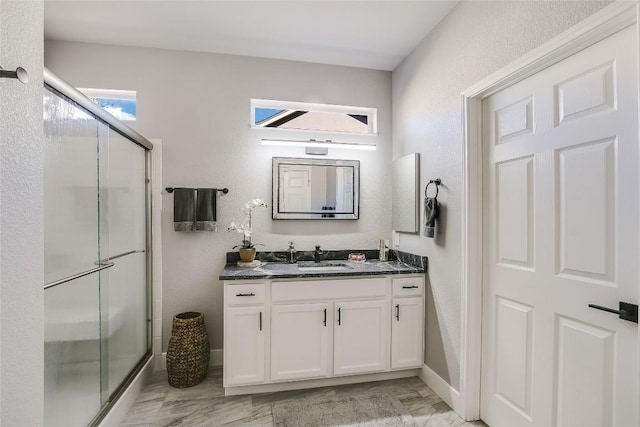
(391, 298), (424, 369)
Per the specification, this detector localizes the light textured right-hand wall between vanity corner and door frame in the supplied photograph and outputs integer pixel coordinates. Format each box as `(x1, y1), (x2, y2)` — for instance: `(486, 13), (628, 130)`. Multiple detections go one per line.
(392, 1), (606, 388)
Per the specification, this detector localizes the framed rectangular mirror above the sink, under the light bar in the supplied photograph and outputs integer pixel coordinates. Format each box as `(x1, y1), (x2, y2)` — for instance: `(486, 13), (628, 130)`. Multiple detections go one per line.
(272, 157), (360, 219)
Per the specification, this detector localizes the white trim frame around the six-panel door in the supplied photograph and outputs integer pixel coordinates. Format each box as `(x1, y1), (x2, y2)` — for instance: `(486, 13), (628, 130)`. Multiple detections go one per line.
(456, 0), (640, 420)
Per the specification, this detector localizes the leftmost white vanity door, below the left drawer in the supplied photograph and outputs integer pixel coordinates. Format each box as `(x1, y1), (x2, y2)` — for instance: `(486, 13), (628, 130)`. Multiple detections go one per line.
(224, 306), (266, 387)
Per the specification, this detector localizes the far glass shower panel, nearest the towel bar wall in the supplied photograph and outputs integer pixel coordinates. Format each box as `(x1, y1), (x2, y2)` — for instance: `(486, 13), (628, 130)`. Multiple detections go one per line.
(99, 124), (148, 401)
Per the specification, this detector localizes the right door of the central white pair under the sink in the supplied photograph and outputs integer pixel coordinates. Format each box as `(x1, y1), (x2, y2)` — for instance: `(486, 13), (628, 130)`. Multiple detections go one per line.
(333, 300), (389, 375)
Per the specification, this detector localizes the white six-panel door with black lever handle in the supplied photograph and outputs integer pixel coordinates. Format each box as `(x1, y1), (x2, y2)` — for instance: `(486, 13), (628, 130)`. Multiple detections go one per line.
(481, 26), (640, 426)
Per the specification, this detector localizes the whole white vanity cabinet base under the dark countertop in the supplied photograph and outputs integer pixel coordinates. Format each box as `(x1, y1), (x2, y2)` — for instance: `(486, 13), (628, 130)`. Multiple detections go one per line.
(224, 275), (424, 394)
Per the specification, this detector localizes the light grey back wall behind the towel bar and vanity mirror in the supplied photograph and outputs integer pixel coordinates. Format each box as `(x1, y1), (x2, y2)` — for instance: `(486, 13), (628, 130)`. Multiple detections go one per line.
(45, 41), (391, 349)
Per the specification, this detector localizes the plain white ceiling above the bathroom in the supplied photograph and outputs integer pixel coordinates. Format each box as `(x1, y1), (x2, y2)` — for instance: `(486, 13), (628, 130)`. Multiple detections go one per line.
(44, 0), (457, 70)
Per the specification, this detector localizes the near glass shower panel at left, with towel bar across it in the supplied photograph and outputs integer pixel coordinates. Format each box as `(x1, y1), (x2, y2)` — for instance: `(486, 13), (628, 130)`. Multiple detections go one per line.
(44, 90), (101, 426)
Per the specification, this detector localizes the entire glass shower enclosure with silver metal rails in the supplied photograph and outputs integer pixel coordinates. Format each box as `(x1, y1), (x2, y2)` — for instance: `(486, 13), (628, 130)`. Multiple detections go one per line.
(44, 70), (152, 426)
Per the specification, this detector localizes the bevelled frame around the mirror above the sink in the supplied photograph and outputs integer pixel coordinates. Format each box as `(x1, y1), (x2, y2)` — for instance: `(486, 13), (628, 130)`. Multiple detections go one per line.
(271, 157), (360, 220)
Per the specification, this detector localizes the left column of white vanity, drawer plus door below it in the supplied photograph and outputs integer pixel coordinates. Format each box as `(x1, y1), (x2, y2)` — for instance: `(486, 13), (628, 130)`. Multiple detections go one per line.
(223, 283), (267, 387)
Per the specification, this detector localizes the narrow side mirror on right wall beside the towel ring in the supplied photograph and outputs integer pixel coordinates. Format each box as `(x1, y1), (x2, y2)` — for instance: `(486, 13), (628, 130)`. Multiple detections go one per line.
(391, 153), (420, 233)
